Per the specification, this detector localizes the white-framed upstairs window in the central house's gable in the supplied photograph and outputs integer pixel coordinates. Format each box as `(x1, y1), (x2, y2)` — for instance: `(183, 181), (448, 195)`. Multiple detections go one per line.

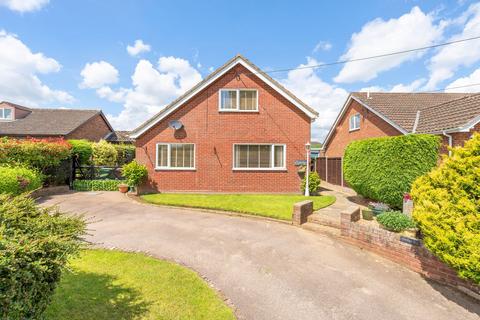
(219, 89), (258, 112)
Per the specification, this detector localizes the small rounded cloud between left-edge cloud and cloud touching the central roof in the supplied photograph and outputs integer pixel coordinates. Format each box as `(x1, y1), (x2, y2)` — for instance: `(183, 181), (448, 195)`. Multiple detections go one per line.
(80, 61), (118, 89)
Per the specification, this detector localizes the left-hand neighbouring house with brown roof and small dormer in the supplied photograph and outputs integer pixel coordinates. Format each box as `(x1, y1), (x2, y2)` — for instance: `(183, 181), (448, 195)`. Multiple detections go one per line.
(0, 101), (113, 141)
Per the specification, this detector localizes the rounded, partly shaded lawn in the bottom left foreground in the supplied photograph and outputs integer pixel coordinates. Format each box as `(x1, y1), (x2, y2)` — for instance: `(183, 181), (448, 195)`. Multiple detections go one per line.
(46, 250), (235, 320)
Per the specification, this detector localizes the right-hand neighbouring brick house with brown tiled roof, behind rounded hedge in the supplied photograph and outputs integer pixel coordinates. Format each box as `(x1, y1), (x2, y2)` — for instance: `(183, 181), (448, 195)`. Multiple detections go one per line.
(317, 92), (480, 185)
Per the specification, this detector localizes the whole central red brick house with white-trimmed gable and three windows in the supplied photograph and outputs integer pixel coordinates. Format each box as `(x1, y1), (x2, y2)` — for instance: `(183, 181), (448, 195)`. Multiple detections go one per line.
(130, 55), (318, 193)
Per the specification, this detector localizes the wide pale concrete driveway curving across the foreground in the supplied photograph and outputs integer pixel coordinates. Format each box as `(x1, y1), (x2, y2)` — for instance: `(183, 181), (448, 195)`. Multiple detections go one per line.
(39, 192), (480, 320)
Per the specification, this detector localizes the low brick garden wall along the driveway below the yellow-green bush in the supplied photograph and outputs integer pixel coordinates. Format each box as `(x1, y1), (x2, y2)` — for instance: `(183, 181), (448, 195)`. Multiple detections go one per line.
(341, 208), (480, 299)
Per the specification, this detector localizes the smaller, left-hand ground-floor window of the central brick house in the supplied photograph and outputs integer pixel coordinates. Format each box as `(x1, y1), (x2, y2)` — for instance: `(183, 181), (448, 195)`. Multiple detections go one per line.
(157, 143), (195, 169)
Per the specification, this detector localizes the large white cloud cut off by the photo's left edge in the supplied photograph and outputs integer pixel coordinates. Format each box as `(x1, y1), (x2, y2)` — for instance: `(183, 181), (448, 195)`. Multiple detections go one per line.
(0, 30), (74, 106)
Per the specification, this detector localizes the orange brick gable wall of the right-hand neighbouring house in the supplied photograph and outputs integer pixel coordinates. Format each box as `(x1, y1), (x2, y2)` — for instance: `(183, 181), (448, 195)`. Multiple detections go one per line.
(325, 100), (402, 157)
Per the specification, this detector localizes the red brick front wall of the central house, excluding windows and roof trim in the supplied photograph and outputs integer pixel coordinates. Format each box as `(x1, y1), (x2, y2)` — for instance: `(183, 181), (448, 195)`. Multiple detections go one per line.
(135, 65), (310, 192)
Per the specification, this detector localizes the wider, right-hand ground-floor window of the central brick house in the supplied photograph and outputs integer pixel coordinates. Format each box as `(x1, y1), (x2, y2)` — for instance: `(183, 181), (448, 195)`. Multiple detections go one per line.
(233, 144), (286, 169)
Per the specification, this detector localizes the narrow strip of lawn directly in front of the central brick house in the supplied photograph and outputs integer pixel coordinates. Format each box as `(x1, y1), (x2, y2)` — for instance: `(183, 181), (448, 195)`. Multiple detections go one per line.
(142, 193), (335, 220)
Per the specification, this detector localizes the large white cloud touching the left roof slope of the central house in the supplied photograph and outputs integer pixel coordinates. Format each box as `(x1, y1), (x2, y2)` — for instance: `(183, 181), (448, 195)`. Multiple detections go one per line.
(103, 57), (202, 130)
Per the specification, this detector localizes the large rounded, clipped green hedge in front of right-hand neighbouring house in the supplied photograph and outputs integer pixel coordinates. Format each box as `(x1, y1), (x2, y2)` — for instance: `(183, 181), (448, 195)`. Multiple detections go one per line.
(343, 134), (440, 208)
